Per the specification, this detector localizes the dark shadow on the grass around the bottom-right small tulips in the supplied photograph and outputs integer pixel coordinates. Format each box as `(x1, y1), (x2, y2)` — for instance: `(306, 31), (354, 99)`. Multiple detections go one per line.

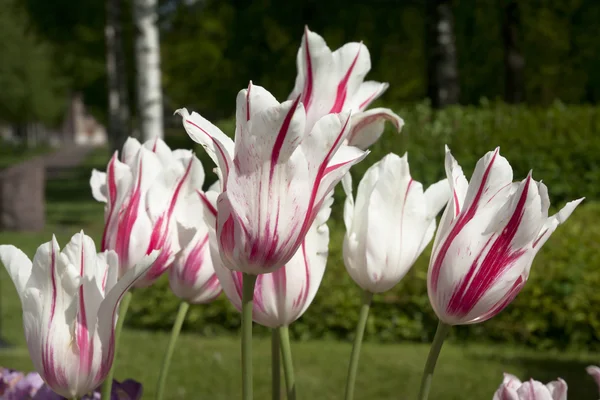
(471, 350), (600, 400)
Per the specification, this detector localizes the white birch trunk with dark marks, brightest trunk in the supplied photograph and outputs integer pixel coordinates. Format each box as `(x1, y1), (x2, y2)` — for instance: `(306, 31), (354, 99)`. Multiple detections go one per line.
(133, 0), (164, 140)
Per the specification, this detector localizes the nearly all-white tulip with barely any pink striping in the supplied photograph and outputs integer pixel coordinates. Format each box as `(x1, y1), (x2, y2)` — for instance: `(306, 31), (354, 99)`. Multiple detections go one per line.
(342, 154), (450, 293)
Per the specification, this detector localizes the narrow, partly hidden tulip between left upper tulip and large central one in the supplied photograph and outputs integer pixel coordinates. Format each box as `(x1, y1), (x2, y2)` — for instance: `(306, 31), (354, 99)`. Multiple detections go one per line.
(169, 184), (221, 304)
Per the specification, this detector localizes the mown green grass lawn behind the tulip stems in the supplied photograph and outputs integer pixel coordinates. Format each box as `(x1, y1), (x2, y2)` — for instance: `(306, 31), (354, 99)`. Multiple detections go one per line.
(0, 143), (600, 400)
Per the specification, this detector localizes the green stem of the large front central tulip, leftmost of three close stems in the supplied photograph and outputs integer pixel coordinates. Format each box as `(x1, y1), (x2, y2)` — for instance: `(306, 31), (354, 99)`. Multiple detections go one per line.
(242, 273), (257, 400)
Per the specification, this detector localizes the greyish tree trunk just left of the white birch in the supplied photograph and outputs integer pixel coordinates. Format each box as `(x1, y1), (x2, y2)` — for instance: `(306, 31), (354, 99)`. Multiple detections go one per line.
(104, 0), (130, 151)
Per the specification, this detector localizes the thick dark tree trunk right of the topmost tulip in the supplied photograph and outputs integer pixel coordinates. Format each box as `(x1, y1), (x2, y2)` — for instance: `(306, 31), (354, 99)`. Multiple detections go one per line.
(425, 0), (460, 108)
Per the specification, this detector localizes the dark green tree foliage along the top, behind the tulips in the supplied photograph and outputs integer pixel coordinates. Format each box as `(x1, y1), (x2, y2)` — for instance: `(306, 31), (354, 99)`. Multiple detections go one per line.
(0, 0), (600, 123)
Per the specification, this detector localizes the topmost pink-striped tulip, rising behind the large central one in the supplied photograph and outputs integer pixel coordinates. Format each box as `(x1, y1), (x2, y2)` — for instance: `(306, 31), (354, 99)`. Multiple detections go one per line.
(289, 27), (404, 149)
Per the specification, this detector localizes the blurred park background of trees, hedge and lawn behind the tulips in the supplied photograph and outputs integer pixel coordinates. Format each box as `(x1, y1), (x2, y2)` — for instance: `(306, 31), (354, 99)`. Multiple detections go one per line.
(0, 0), (600, 400)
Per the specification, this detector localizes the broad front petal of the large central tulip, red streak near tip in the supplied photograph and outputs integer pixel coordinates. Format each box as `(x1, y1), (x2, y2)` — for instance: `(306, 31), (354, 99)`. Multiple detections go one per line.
(217, 95), (311, 269)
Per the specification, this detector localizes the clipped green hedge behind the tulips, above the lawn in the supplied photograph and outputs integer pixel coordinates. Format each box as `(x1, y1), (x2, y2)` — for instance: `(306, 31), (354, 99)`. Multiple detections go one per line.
(128, 104), (600, 349)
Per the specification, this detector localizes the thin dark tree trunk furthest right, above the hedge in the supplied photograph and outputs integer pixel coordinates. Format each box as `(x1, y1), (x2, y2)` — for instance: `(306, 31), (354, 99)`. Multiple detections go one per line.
(502, 0), (525, 104)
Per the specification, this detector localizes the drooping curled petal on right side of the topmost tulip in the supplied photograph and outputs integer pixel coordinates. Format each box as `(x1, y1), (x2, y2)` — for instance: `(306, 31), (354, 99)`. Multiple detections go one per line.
(348, 108), (404, 150)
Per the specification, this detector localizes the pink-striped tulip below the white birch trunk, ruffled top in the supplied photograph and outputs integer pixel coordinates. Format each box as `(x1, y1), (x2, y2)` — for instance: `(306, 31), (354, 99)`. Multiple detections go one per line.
(90, 138), (204, 287)
